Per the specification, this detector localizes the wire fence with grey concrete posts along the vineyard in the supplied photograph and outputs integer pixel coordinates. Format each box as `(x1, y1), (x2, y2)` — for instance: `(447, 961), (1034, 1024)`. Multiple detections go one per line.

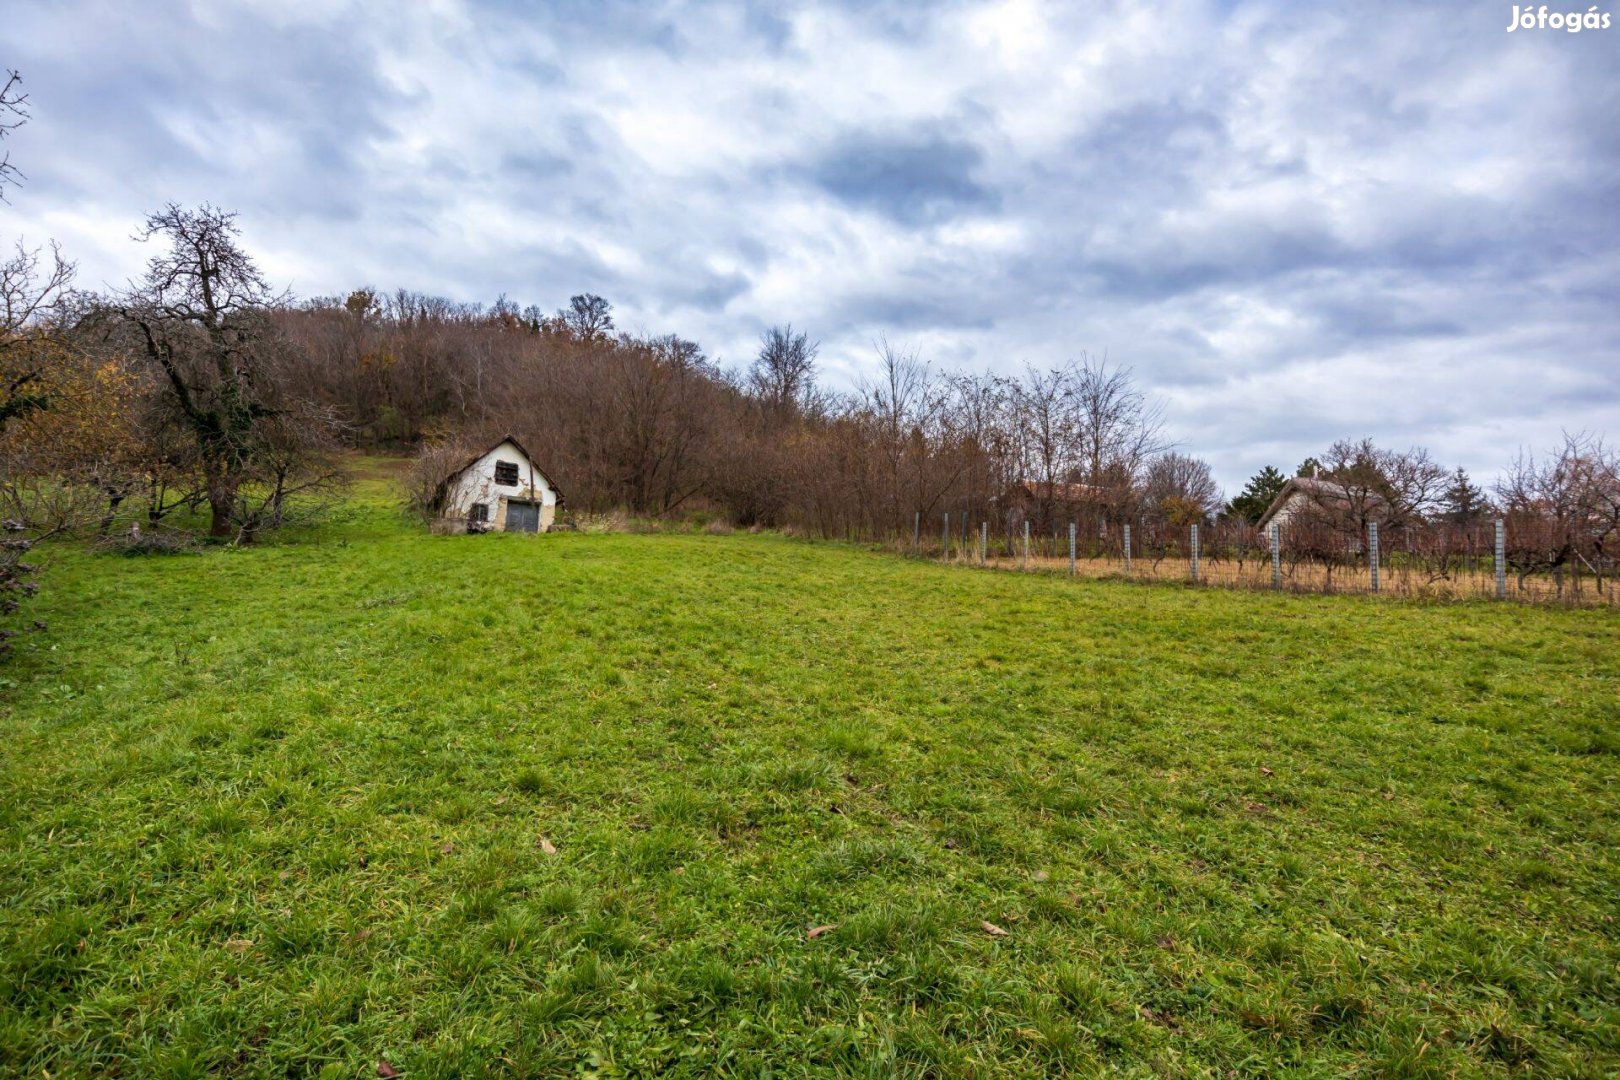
(894, 515), (1620, 606)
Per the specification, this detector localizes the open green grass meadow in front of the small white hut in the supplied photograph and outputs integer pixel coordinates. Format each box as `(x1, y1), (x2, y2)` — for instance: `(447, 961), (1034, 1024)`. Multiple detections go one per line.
(0, 484), (1620, 1077)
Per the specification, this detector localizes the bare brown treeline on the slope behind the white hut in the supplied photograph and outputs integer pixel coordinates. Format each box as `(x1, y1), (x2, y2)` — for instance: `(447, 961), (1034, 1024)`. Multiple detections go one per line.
(275, 290), (1220, 536)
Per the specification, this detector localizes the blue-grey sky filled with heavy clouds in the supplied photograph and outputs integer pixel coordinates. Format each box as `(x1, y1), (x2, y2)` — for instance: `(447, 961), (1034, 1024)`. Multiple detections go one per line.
(0, 0), (1620, 489)
